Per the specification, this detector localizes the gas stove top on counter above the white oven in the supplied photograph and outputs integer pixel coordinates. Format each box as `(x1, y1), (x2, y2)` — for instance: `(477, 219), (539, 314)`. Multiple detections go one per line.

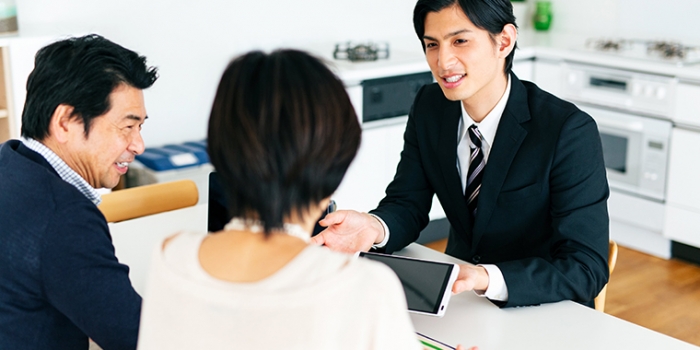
(585, 38), (700, 66)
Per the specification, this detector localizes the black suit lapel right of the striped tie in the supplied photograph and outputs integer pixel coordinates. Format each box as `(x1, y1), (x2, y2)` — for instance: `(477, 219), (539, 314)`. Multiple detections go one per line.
(465, 75), (530, 247)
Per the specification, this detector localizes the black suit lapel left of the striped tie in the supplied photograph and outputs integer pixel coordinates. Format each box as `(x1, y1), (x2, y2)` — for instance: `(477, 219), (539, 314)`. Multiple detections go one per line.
(438, 100), (472, 233)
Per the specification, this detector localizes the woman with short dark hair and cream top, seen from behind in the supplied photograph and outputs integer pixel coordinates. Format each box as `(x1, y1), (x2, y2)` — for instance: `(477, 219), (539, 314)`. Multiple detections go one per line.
(134, 50), (421, 350)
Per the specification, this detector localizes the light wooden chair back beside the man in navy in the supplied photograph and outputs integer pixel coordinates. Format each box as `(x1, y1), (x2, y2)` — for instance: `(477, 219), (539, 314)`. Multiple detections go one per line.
(98, 180), (199, 222)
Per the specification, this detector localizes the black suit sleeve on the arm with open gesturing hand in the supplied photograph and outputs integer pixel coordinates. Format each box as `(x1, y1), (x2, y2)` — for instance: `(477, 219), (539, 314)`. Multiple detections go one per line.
(370, 86), (435, 252)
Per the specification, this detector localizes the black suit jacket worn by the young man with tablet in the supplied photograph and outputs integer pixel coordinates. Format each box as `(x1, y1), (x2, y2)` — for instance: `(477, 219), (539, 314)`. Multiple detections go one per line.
(372, 74), (609, 306)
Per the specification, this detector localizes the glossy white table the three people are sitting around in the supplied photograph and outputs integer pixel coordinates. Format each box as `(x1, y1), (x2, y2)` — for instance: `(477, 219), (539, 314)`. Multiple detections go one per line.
(109, 205), (700, 350)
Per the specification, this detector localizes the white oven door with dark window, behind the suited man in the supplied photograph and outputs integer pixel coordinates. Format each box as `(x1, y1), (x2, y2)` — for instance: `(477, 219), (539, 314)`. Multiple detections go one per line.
(580, 105), (672, 202)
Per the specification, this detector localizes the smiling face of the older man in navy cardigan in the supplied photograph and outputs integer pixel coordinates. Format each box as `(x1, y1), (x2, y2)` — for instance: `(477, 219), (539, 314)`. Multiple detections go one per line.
(64, 84), (146, 188)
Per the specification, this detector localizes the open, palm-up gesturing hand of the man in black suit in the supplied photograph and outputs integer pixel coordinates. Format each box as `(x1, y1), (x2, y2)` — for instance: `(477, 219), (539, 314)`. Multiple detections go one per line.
(311, 210), (384, 253)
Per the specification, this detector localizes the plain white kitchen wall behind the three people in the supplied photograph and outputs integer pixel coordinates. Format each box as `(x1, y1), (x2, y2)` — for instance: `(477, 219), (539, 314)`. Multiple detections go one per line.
(12, 0), (700, 146)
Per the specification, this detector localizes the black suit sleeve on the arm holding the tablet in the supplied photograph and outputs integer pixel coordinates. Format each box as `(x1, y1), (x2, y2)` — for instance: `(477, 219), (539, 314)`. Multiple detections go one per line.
(496, 111), (609, 307)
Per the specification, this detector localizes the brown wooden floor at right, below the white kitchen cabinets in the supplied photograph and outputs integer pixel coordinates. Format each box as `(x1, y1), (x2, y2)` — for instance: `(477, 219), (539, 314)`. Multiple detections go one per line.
(426, 240), (700, 346)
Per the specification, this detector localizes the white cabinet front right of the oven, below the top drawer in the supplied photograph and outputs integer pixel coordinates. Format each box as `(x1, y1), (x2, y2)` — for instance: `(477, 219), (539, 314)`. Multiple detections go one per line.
(664, 127), (700, 248)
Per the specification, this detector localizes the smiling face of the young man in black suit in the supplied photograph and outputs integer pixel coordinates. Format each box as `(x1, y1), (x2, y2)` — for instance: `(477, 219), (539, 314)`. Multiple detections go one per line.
(423, 5), (505, 103)
